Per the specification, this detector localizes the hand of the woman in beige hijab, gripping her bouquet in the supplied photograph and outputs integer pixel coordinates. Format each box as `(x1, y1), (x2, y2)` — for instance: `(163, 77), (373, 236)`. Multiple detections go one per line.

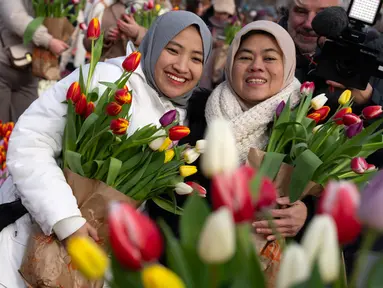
(253, 197), (307, 241)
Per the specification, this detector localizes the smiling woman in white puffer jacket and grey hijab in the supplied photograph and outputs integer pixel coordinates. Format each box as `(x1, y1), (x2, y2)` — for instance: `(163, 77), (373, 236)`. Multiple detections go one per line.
(0, 11), (211, 288)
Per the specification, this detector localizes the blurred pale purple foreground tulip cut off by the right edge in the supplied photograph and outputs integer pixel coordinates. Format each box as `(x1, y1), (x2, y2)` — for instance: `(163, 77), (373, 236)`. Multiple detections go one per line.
(358, 171), (383, 231)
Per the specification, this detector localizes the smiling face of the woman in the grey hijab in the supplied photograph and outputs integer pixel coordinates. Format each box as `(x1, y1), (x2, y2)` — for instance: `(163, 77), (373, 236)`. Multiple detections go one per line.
(154, 26), (203, 98)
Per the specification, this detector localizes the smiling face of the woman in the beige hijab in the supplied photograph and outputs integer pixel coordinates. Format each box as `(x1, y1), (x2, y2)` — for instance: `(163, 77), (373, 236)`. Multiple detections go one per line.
(231, 34), (284, 105)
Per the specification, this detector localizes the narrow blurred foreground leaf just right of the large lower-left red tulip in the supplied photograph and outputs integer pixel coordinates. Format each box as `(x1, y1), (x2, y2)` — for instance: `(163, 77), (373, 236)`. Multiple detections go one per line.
(158, 219), (194, 288)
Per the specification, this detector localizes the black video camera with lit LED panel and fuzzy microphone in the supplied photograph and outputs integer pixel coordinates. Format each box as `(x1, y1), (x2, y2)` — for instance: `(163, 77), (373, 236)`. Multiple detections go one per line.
(312, 0), (383, 90)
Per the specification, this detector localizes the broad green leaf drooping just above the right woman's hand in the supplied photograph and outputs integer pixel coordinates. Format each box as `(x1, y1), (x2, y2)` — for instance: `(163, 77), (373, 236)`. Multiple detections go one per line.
(289, 149), (323, 203)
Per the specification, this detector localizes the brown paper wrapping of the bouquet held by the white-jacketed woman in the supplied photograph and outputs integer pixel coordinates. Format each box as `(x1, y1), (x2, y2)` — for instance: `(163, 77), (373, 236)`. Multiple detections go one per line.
(20, 169), (136, 288)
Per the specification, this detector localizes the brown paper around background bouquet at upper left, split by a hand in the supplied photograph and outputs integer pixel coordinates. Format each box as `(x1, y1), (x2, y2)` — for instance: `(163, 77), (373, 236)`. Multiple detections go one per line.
(32, 17), (74, 80)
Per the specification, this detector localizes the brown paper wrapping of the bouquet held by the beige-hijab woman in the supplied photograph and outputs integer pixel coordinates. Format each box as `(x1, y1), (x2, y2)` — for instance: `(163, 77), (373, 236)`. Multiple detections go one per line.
(247, 148), (323, 288)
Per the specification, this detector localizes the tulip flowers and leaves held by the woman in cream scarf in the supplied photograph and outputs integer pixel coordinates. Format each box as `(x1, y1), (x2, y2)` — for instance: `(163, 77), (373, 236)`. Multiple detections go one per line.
(261, 82), (383, 202)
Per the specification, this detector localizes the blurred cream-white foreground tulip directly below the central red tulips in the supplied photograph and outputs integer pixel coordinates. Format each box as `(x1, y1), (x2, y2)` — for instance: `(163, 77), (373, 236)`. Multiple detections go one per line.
(197, 207), (236, 264)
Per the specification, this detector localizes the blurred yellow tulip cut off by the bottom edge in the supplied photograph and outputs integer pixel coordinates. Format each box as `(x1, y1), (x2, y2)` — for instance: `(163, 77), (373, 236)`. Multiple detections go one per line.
(141, 264), (186, 288)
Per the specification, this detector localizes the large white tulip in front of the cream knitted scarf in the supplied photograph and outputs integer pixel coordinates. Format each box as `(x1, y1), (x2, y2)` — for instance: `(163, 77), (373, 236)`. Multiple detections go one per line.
(201, 118), (239, 177)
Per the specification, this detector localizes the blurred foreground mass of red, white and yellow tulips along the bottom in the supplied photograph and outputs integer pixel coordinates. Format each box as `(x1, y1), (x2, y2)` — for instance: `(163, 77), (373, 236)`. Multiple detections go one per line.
(68, 120), (383, 288)
